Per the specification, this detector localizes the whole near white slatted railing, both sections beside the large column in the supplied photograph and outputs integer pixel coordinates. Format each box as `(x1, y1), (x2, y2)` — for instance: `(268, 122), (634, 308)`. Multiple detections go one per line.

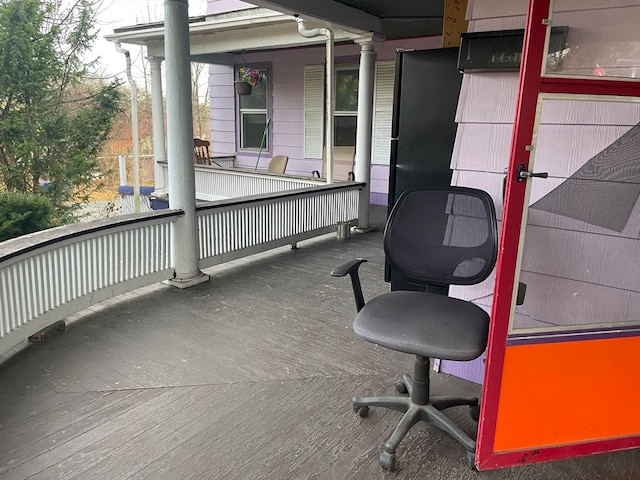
(0, 182), (364, 361)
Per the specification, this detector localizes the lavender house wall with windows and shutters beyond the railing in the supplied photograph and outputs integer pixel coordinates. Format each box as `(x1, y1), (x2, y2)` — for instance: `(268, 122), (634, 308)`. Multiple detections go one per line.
(209, 1), (450, 205)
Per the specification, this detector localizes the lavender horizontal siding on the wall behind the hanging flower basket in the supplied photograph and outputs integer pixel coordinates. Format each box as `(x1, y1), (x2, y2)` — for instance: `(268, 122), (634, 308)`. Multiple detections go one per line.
(209, 23), (441, 205)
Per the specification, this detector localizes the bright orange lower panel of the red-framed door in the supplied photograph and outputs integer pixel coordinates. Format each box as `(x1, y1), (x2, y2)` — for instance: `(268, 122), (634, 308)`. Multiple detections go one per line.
(494, 337), (640, 452)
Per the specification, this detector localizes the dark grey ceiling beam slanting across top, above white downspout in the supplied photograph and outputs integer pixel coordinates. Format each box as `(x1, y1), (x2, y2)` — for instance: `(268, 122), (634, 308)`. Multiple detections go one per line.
(245, 0), (382, 34)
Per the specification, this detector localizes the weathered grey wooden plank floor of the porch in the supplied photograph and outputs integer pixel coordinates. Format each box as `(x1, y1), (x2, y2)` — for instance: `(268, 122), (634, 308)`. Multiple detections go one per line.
(0, 208), (640, 480)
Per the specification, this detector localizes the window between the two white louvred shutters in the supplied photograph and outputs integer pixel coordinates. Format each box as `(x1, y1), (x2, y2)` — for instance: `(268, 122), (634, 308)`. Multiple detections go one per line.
(334, 66), (358, 147)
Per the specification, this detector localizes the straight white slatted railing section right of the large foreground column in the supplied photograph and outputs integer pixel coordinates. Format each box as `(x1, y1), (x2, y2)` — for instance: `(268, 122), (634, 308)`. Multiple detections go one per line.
(197, 183), (364, 268)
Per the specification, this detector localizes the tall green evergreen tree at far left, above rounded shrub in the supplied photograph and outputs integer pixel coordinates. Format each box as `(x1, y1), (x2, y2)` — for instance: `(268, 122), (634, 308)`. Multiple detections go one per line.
(0, 0), (120, 223)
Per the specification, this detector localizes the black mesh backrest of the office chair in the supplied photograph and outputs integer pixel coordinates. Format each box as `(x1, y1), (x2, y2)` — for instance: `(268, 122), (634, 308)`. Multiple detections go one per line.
(384, 186), (498, 285)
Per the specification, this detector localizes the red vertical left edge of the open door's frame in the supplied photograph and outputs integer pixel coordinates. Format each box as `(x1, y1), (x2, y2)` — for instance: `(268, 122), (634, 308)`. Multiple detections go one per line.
(476, 0), (550, 468)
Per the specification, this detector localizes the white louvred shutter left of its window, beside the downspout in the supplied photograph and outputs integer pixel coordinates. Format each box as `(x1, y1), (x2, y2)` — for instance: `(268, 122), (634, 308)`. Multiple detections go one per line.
(304, 65), (324, 158)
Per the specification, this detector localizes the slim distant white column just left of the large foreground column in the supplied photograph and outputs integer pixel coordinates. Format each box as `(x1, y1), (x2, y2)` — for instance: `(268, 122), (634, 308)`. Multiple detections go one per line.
(147, 56), (167, 195)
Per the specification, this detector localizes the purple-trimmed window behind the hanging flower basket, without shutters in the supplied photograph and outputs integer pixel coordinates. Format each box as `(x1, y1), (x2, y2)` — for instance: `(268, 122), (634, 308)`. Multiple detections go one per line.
(238, 68), (269, 151)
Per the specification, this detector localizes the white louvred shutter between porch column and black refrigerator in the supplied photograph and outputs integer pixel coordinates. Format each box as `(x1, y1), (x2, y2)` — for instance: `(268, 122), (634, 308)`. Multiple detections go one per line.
(371, 60), (395, 165)
